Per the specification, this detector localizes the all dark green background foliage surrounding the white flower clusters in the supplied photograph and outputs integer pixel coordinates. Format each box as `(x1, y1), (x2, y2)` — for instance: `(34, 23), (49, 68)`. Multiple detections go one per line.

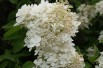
(0, 0), (103, 68)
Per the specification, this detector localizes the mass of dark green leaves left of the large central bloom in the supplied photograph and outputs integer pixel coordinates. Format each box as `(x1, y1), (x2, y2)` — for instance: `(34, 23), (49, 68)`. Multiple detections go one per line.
(0, 0), (40, 68)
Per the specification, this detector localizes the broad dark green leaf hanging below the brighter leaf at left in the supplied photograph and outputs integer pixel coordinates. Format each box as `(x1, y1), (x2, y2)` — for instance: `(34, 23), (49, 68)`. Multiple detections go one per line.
(12, 29), (26, 53)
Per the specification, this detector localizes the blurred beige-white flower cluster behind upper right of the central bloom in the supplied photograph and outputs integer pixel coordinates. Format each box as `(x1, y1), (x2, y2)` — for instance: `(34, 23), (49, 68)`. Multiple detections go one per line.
(77, 4), (96, 29)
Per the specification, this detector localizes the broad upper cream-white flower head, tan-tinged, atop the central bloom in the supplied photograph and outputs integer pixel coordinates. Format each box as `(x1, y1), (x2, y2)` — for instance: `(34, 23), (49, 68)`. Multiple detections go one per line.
(15, 1), (80, 36)
